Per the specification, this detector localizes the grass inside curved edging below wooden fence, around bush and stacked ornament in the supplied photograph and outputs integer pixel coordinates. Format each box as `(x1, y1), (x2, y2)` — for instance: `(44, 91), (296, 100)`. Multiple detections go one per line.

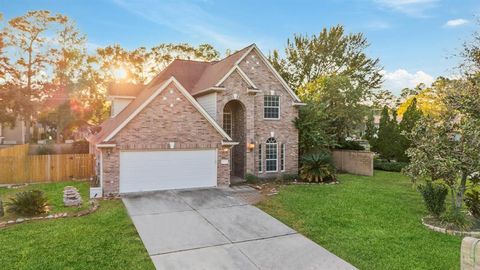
(0, 181), (90, 221)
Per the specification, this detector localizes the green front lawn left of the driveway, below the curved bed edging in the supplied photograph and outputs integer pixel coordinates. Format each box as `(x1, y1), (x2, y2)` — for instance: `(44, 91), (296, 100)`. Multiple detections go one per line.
(0, 200), (154, 269)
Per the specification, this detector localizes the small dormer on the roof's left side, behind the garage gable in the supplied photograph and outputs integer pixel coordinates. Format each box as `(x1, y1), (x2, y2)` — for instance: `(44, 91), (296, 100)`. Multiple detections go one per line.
(107, 83), (145, 117)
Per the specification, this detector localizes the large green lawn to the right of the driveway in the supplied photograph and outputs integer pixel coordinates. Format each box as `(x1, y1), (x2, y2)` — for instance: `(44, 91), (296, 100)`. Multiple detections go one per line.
(258, 171), (461, 269)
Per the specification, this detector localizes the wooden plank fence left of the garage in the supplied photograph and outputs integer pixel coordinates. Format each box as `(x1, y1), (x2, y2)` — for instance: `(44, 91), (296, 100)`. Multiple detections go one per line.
(0, 145), (95, 184)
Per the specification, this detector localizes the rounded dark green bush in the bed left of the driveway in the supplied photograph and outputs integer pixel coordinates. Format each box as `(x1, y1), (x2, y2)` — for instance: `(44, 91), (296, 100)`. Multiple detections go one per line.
(6, 190), (47, 216)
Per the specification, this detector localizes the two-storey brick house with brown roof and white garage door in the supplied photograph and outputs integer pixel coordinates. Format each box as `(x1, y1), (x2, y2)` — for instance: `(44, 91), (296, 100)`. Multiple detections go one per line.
(89, 44), (303, 194)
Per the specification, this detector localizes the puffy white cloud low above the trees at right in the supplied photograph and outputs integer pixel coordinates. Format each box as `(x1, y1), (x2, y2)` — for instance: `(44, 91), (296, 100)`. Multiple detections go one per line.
(382, 69), (435, 95)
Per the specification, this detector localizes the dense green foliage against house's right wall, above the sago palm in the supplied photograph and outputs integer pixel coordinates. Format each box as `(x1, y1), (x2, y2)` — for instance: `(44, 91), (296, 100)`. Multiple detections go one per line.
(295, 103), (333, 156)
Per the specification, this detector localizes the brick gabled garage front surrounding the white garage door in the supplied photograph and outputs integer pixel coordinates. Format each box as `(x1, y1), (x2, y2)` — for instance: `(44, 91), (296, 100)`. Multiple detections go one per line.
(102, 83), (230, 194)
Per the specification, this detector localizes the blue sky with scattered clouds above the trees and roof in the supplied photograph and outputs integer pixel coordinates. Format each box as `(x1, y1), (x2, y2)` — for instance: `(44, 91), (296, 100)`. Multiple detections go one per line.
(0, 0), (480, 94)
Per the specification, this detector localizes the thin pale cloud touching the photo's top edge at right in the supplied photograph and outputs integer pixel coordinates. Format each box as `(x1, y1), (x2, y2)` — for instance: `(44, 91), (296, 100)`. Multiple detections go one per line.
(374, 0), (439, 17)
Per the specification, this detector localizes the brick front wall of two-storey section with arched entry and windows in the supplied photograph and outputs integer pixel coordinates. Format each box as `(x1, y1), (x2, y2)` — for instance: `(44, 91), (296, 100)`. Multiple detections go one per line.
(217, 50), (298, 178)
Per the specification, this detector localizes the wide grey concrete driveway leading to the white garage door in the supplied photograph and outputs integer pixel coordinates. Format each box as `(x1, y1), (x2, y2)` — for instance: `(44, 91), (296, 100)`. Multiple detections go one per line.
(123, 189), (355, 270)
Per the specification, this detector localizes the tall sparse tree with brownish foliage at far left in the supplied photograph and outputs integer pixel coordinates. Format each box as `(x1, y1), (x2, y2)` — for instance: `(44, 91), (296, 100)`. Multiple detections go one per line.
(3, 10), (66, 142)
